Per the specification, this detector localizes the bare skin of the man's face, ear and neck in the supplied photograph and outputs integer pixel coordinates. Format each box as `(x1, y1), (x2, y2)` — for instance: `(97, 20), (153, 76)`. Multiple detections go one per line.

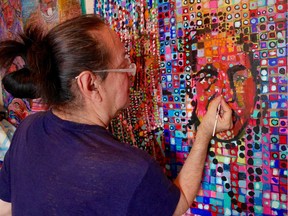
(52, 27), (131, 127)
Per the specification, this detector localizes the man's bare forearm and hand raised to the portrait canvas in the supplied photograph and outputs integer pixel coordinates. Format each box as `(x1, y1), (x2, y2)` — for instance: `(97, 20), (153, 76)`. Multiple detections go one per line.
(174, 96), (232, 216)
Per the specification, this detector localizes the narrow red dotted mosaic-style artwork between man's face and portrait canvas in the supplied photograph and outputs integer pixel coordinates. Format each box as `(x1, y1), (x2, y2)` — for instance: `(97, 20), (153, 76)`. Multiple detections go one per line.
(94, 1), (166, 167)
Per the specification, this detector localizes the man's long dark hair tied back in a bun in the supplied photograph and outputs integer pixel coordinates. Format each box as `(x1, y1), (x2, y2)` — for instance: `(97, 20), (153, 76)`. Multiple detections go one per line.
(0, 14), (110, 105)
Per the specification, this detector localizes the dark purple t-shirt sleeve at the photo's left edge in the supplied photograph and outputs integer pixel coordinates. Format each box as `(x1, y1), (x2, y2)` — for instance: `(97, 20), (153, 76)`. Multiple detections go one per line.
(0, 149), (11, 202)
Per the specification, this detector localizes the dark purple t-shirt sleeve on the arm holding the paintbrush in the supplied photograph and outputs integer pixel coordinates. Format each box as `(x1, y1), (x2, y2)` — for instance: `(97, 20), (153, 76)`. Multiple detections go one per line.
(127, 159), (180, 216)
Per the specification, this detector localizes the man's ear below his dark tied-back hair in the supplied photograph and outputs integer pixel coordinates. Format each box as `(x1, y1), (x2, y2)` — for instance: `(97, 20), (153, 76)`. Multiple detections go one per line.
(76, 71), (101, 99)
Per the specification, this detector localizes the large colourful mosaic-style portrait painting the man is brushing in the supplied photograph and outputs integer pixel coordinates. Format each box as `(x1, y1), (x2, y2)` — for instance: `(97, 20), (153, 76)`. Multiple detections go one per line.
(158, 1), (287, 215)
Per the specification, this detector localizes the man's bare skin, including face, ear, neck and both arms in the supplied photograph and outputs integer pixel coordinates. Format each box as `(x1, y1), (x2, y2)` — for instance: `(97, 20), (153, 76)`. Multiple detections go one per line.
(0, 24), (232, 216)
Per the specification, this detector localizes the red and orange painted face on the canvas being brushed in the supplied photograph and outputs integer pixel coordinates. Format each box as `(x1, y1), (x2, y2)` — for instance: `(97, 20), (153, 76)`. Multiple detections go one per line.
(193, 34), (256, 141)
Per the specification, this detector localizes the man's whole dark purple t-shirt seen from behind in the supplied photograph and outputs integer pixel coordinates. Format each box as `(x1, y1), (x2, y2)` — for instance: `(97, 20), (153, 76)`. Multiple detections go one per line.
(0, 111), (180, 216)
